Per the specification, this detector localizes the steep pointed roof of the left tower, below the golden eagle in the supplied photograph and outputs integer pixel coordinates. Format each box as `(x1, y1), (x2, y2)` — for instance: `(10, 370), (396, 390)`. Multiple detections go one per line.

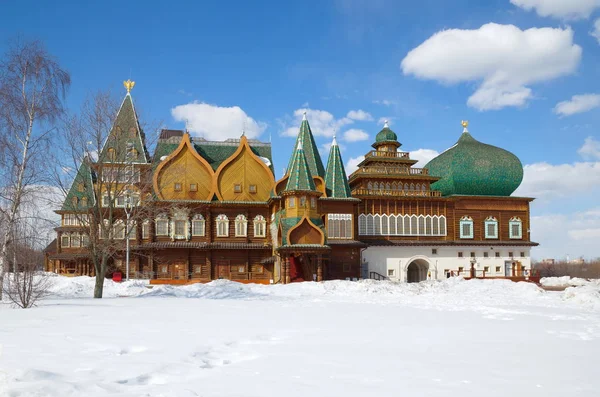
(98, 92), (149, 164)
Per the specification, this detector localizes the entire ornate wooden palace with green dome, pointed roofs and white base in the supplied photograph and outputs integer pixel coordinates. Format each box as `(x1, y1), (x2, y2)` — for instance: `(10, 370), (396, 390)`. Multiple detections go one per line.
(46, 84), (536, 284)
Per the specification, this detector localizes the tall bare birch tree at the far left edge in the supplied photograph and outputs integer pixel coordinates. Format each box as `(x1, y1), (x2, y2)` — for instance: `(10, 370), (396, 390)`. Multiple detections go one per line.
(0, 41), (71, 299)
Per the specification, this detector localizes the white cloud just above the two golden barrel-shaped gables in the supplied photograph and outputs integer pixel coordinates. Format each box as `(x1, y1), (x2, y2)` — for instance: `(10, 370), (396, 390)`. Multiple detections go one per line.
(171, 102), (267, 141)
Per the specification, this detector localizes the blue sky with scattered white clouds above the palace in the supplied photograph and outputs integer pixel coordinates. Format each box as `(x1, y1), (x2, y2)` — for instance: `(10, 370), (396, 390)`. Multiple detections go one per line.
(0, 0), (600, 258)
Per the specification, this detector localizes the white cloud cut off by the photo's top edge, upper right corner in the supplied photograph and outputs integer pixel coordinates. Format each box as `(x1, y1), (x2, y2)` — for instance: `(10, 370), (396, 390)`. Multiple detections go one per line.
(510, 0), (600, 19)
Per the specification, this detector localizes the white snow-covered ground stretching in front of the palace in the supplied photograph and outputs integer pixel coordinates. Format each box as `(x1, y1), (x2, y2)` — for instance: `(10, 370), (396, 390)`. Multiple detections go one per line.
(0, 277), (600, 397)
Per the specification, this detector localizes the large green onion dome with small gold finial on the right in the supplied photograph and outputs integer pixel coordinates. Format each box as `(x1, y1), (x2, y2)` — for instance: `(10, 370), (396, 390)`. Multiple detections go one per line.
(424, 122), (523, 196)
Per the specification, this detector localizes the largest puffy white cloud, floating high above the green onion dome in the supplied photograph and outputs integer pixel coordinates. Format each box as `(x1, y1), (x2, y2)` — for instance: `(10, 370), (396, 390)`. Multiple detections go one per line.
(401, 23), (582, 111)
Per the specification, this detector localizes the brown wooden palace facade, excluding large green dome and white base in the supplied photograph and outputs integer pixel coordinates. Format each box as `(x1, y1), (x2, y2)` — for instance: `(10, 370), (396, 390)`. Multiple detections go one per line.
(46, 88), (534, 284)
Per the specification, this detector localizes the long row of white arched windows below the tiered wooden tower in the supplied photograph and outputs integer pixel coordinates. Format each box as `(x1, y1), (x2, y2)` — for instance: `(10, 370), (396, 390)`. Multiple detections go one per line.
(358, 214), (446, 236)
